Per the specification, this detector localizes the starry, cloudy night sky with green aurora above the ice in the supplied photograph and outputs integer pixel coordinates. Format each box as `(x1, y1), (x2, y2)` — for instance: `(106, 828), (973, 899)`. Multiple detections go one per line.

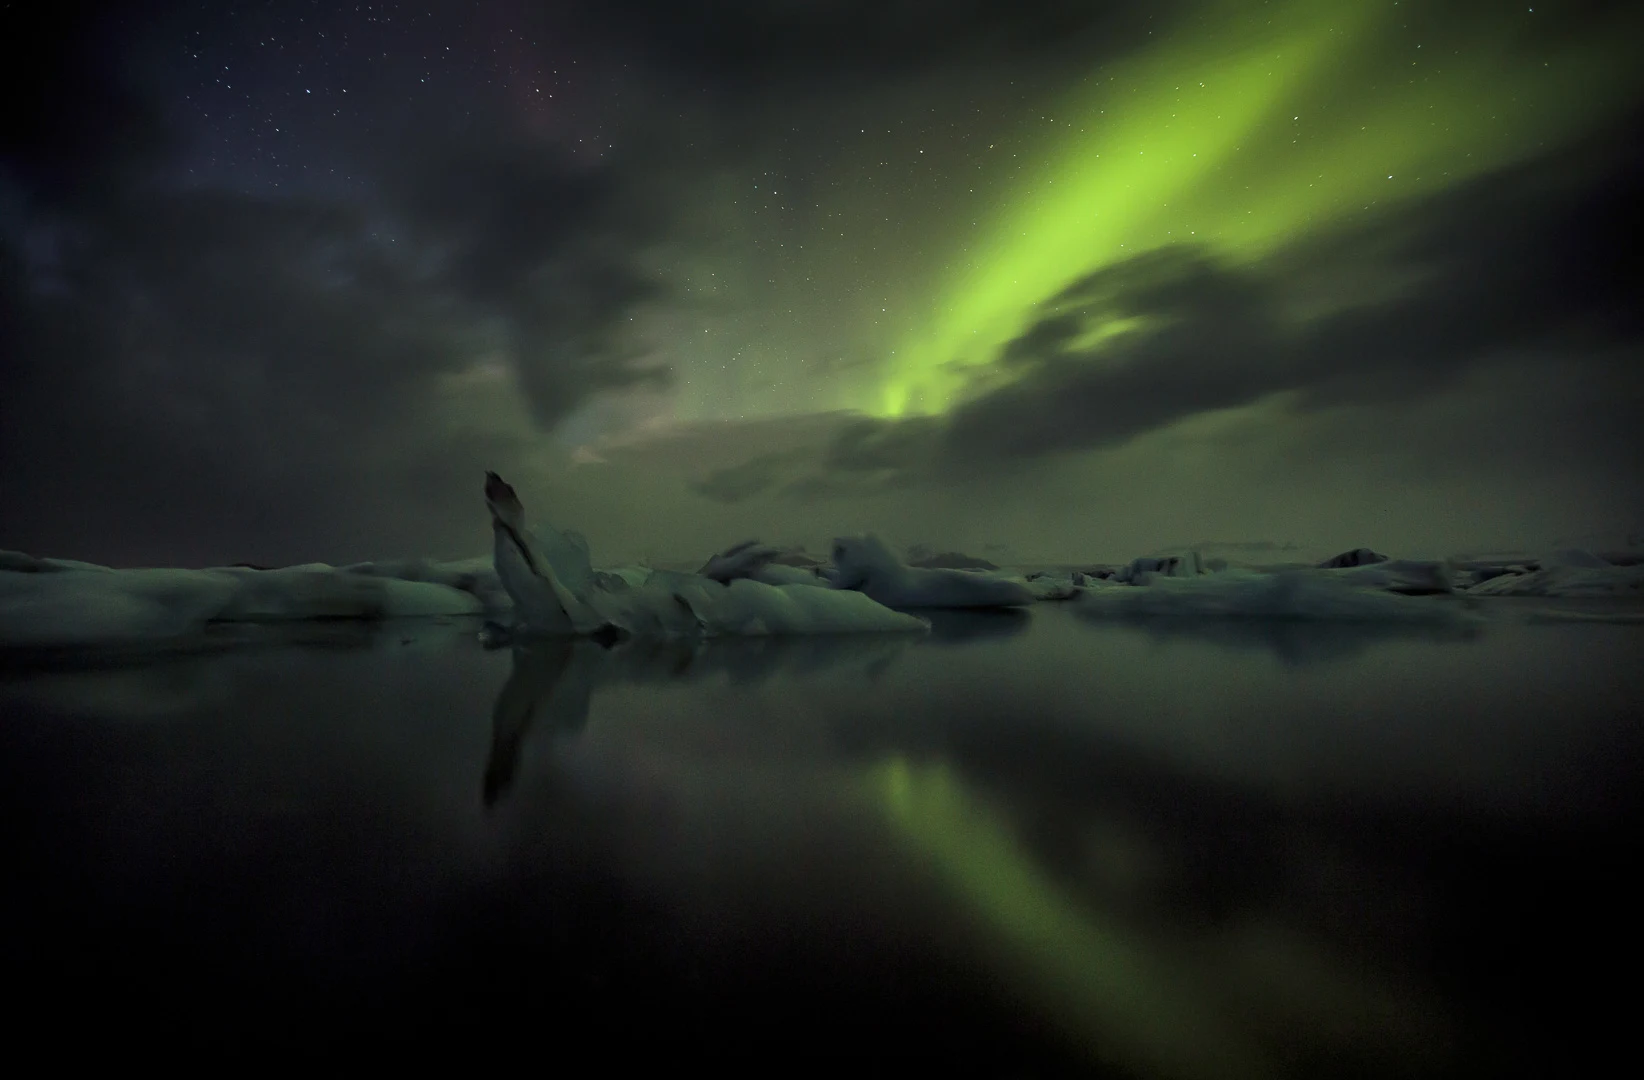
(0, 0), (1644, 565)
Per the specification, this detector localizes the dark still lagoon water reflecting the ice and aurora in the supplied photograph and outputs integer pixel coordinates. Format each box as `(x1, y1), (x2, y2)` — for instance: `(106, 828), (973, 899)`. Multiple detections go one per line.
(0, 605), (1644, 1077)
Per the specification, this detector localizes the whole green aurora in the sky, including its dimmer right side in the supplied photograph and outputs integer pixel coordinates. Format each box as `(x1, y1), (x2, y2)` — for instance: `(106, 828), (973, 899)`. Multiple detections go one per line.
(861, 0), (1644, 418)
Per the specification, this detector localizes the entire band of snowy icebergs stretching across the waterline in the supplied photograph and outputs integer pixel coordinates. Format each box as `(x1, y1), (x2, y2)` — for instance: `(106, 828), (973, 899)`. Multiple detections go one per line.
(0, 475), (1644, 654)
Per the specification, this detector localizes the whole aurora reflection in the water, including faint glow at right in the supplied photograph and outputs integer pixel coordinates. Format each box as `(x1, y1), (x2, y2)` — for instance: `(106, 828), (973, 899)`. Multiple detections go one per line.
(861, 756), (1447, 1080)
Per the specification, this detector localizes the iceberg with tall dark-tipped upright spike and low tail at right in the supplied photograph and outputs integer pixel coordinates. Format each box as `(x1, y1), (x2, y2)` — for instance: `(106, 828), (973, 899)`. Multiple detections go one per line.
(485, 473), (929, 638)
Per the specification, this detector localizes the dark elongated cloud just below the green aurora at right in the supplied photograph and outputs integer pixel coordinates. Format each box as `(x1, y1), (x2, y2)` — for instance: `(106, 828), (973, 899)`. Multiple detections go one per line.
(769, 118), (1644, 483)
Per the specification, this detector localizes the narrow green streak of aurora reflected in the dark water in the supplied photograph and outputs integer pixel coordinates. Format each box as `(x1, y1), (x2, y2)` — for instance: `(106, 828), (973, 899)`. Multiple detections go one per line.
(868, 758), (1271, 1077)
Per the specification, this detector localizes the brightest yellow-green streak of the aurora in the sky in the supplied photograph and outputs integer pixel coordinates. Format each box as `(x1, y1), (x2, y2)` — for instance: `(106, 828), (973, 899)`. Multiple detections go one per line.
(881, 5), (1369, 416)
